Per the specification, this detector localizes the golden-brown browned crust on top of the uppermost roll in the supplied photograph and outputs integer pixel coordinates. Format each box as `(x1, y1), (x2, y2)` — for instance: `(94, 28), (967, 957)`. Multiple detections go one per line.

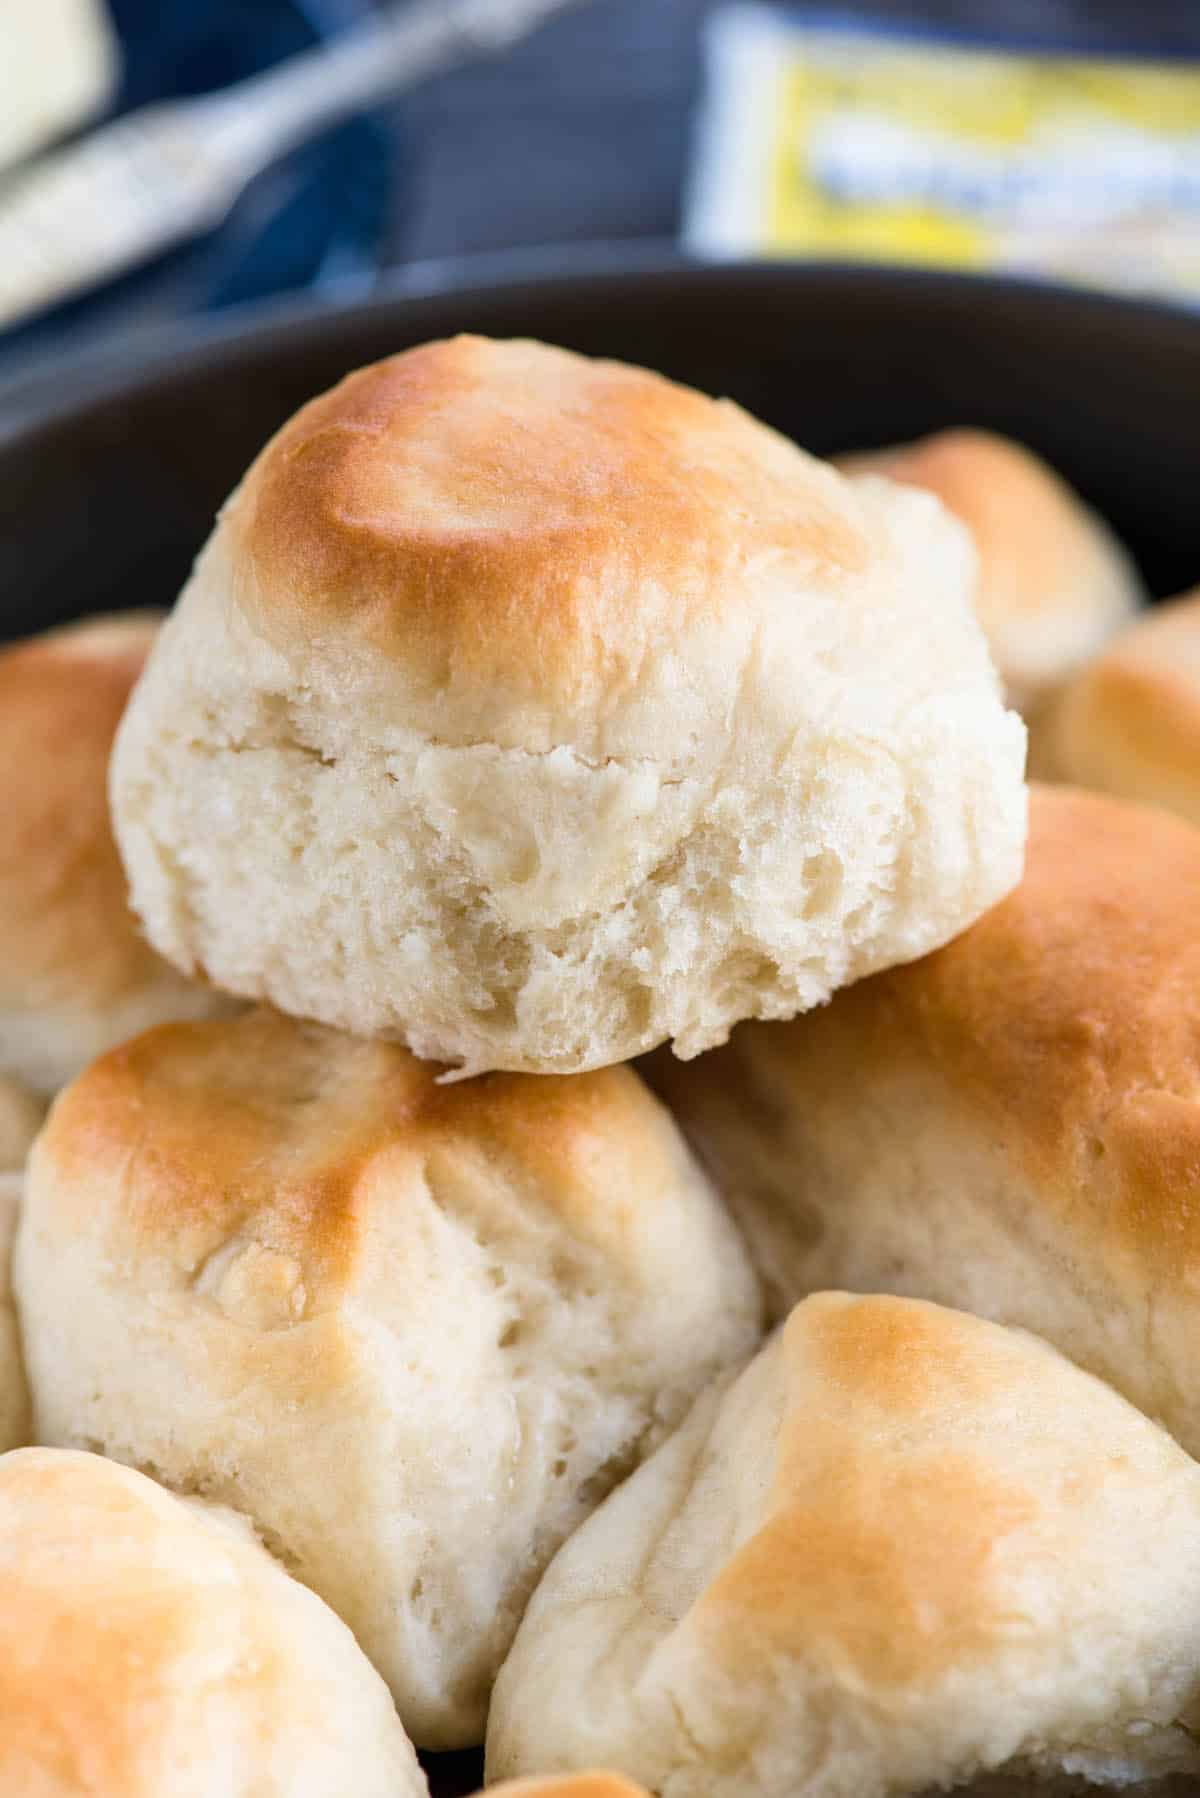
(230, 336), (876, 737)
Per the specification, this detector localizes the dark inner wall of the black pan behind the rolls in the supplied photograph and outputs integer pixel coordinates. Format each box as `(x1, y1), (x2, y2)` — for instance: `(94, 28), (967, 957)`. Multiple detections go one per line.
(0, 263), (1200, 636)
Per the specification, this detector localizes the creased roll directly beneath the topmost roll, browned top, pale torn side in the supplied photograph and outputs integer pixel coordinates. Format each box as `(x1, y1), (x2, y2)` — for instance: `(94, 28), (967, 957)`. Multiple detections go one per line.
(18, 1010), (759, 1748)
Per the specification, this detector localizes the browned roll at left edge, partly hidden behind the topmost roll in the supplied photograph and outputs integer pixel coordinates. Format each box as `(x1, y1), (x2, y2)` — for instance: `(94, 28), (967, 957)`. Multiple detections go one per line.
(0, 613), (223, 1093)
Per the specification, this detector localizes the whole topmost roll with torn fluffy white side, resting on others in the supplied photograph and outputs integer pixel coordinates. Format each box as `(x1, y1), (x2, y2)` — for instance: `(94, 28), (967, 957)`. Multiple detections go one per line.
(112, 338), (1024, 1073)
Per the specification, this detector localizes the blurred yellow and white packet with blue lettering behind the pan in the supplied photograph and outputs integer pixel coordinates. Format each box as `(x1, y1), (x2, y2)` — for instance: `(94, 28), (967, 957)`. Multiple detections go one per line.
(684, 5), (1200, 300)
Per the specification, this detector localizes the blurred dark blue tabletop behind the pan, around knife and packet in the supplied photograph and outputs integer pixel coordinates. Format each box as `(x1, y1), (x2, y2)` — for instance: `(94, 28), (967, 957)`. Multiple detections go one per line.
(0, 0), (1200, 374)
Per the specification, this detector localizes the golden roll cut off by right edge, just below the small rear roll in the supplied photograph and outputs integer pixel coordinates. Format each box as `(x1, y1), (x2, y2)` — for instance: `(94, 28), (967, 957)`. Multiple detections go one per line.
(1038, 588), (1200, 823)
